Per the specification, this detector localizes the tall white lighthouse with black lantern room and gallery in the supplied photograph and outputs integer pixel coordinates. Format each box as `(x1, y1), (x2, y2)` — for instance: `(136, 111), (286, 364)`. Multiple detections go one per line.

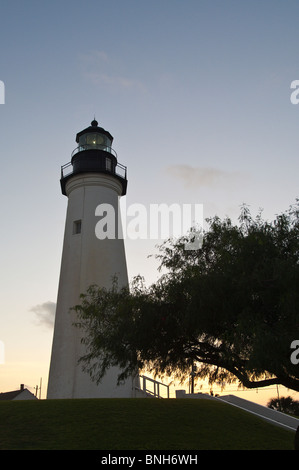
(47, 119), (134, 399)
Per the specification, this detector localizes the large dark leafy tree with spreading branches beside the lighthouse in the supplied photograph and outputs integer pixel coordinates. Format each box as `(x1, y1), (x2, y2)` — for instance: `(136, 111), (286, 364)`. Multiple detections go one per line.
(74, 200), (299, 391)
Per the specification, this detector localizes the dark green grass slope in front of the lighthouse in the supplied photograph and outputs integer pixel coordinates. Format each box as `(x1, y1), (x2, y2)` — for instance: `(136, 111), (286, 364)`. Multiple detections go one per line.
(0, 398), (295, 450)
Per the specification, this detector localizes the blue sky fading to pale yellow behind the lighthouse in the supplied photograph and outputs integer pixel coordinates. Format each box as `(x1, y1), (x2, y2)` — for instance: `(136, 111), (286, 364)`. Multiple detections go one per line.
(0, 0), (299, 401)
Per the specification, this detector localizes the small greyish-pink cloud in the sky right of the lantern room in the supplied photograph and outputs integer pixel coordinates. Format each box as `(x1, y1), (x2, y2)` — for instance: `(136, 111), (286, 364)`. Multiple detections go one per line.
(166, 165), (245, 188)
